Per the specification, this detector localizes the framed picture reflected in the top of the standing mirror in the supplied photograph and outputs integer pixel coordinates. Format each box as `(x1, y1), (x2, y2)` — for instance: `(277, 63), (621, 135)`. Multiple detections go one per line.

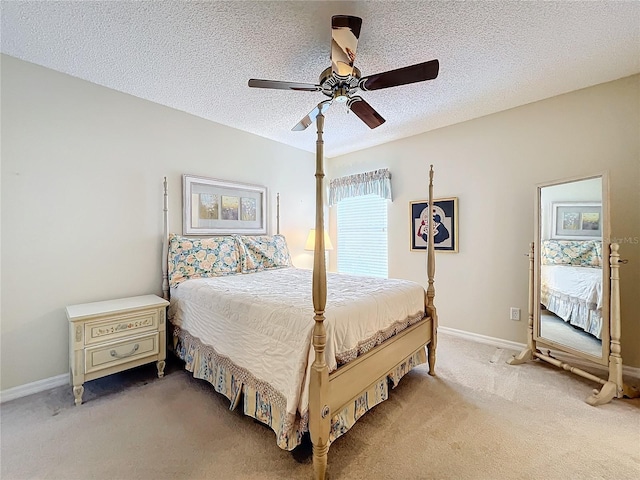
(551, 202), (602, 240)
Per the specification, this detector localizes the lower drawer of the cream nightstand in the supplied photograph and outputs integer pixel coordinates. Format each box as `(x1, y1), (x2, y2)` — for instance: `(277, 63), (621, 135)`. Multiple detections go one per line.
(84, 332), (159, 373)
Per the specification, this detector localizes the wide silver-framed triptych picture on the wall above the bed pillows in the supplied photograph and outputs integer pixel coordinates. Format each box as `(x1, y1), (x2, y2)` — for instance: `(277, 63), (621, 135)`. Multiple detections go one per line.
(182, 175), (267, 235)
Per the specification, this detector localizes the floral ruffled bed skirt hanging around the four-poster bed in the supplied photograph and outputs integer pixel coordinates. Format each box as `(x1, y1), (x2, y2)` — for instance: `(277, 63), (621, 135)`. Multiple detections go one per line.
(173, 327), (427, 450)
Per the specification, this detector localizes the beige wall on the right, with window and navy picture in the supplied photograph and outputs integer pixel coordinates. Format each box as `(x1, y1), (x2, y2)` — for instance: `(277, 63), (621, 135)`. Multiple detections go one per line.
(328, 75), (640, 367)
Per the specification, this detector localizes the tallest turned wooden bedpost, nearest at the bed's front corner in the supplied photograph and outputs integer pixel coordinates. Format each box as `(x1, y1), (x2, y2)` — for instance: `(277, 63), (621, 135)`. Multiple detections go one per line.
(309, 111), (331, 480)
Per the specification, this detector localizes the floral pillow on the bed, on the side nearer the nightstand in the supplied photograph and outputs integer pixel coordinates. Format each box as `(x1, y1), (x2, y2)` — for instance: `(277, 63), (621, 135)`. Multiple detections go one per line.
(169, 234), (240, 287)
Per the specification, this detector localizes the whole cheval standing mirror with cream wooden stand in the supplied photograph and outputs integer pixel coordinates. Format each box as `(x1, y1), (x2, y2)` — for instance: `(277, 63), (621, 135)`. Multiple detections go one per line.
(508, 173), (623, 405)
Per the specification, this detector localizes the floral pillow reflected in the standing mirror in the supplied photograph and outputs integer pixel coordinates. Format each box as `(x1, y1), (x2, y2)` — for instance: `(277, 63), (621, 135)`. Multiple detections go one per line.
(542, 240), (602, 268)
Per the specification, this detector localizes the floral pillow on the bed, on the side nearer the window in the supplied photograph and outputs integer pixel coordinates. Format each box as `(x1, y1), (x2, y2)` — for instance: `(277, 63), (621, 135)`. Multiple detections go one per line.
(238, 235), (291, 273)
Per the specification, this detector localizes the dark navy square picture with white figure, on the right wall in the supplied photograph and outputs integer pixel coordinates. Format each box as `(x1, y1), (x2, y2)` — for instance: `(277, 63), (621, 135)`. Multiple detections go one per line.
(409, 197), (458, 253)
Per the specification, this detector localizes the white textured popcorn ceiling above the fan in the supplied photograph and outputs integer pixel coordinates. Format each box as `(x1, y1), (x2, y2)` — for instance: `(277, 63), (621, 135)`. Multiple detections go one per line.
(1, 1), (640, 157)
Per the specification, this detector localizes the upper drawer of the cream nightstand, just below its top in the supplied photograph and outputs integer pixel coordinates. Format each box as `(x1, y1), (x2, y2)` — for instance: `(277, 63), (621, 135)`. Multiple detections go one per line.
(84, 310), (158, 345)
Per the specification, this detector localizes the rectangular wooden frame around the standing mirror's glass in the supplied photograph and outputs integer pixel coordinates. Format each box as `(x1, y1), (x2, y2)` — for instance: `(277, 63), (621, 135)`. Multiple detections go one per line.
(533, 171), (611, 366)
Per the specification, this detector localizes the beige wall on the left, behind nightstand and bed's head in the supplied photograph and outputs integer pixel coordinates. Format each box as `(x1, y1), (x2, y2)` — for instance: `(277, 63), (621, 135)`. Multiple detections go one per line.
(1, 56), (315, 390)
